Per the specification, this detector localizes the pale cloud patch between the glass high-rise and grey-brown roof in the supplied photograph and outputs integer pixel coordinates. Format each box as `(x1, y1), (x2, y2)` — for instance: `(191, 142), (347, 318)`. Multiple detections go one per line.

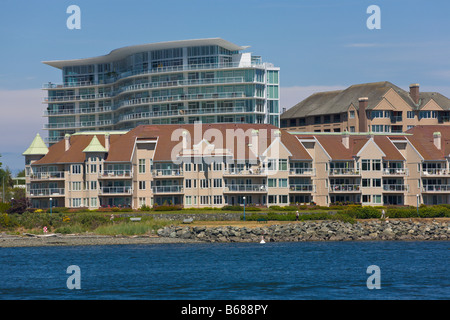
(280, 85), (347, 111)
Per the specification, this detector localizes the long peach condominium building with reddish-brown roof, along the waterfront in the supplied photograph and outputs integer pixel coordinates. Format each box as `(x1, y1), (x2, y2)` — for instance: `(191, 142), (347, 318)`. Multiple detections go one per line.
(24, 124), (450, 208)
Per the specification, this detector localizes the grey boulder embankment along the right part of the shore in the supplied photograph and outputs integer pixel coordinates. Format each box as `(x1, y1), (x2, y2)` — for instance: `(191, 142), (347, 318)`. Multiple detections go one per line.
(157, 220), (450, 242)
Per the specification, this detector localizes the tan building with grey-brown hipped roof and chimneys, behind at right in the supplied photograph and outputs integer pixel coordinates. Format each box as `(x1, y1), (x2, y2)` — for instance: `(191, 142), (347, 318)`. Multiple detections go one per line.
(281, 81), (450, 133)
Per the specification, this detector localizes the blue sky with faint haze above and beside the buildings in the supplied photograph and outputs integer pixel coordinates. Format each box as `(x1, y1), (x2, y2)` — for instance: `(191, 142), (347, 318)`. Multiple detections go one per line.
(0, 0), (450, 172)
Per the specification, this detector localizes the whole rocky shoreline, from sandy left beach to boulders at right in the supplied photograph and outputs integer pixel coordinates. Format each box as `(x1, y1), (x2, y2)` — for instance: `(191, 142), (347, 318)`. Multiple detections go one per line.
(0, 219), (450, 247)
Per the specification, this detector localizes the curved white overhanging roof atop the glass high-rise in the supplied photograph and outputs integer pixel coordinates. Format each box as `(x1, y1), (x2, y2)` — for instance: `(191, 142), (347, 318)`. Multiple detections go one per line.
(42, 38), (249, 69)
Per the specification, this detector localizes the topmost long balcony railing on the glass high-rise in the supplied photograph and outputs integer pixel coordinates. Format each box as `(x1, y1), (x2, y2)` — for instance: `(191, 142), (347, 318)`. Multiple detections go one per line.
(43, 62), (273, 89)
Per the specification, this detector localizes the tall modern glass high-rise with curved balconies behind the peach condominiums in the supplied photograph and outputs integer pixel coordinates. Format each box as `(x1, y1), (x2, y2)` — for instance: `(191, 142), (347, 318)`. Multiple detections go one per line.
(44, 38), (280, 145)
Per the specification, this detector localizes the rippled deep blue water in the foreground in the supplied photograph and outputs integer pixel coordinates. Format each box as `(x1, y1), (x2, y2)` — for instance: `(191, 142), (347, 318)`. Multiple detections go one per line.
(0, 241), (450, 300)
